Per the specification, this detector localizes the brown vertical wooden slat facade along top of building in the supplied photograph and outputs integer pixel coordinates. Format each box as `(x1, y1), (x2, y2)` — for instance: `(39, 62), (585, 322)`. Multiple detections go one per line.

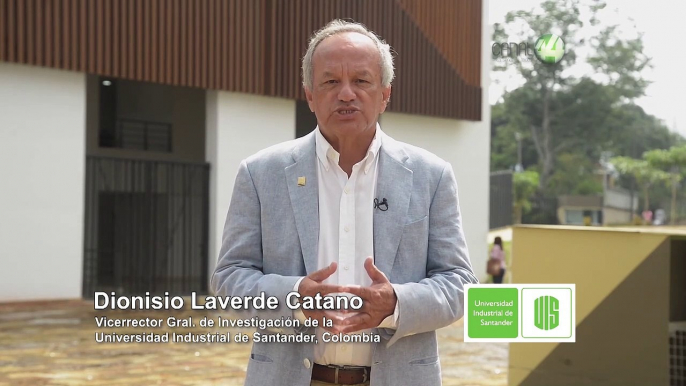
(0, 0), (482, 120)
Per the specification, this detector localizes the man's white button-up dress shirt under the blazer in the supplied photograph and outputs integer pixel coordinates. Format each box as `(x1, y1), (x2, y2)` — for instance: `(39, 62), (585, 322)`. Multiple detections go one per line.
(295, 124), (399, 366)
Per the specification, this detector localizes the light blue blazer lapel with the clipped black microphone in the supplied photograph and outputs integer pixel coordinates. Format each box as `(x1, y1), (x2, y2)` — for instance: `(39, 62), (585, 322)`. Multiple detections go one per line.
(374, 135), (412, 278)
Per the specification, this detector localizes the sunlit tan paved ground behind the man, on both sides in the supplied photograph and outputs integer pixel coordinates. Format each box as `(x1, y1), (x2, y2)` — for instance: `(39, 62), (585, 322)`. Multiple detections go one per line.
(0, 301), (508, 386)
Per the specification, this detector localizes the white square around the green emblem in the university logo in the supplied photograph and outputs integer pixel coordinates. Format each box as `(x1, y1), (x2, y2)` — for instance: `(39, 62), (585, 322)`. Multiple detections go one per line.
(521, 288), (572, 338)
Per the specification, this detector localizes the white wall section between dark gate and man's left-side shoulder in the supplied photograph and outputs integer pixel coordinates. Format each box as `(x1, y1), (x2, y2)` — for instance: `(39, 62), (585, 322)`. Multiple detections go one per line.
(206, 91), (295, 275)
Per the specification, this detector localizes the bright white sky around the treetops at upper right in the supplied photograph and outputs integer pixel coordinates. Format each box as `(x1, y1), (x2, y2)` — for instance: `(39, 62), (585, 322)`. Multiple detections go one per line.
(488, 0), (686, 137)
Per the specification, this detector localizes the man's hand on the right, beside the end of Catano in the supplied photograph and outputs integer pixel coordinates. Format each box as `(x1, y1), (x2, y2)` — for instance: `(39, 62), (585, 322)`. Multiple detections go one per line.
(340, 258), (398, 333)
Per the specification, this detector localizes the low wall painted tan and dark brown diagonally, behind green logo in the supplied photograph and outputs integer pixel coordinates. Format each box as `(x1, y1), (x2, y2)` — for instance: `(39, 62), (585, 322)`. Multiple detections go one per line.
(508, 226), (676, 386)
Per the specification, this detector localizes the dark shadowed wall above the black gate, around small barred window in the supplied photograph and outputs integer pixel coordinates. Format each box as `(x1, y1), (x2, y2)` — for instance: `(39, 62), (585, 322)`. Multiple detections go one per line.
(87, 75), (205, 162)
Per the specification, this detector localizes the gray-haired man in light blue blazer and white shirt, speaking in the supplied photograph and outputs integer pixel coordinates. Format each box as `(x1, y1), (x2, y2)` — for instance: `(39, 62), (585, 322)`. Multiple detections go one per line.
(211, 20), (477, 386)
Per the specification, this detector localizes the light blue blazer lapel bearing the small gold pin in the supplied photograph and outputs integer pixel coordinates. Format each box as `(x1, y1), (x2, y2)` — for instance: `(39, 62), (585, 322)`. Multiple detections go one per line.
(285, 133), (319, 275)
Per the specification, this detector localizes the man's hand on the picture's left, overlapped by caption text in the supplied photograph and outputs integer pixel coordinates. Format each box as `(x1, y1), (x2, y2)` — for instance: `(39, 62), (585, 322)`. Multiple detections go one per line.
(298, 262), (344, 334)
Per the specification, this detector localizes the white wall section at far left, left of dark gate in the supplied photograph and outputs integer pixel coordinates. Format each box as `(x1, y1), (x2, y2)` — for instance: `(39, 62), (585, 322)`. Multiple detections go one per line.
(0, 63), (86, 302)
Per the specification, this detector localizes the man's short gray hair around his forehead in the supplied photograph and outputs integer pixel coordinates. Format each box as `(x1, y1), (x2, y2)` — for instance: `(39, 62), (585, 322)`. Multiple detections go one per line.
(302, 19), (395, 90)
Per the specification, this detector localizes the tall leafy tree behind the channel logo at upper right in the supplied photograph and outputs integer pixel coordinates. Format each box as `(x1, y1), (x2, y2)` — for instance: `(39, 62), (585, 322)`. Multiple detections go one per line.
(493, 0), (649, 189)
